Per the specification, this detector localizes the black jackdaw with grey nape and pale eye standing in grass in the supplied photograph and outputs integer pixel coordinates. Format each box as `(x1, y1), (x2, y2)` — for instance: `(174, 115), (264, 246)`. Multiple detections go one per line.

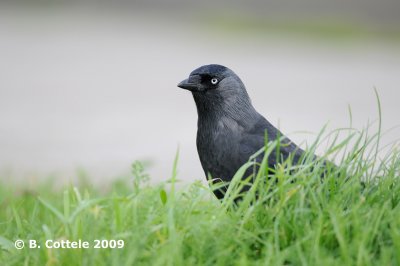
(178, 64), (312, 198)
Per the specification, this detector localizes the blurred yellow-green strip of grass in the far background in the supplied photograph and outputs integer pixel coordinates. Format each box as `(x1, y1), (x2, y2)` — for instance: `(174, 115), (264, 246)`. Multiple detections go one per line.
(200, 12), (400, 44)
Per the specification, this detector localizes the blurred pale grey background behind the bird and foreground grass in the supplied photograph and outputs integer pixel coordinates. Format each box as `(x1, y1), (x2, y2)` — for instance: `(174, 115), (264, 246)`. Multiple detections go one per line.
(0, 0), (400, 184)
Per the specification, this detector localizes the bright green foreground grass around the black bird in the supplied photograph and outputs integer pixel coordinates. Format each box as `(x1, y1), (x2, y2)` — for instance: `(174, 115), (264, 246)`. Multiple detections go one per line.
(0, 123), (400, 265)
